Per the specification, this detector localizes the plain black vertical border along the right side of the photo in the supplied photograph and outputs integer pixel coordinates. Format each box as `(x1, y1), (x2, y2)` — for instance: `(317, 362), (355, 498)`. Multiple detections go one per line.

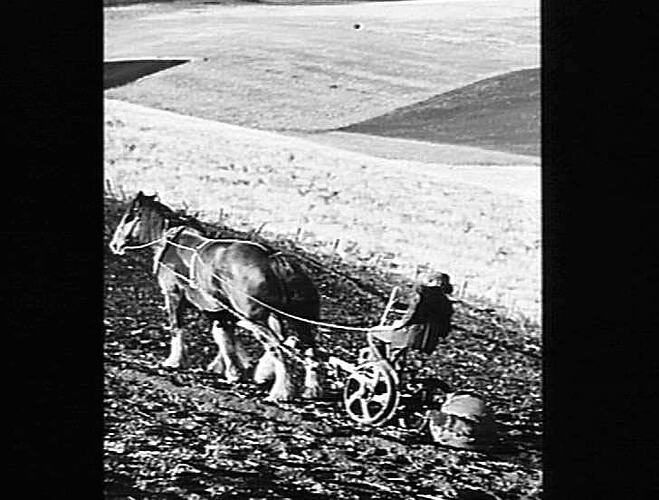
(542, 0), (659, 498)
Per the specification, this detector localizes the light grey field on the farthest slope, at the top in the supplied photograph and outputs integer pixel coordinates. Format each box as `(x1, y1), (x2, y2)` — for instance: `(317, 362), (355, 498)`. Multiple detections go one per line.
(104, 0), (540, 131)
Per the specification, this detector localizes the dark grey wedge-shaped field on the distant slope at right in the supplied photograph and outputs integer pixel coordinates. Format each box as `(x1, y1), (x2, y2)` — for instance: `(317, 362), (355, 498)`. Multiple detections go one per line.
(339, 68), (540, 155)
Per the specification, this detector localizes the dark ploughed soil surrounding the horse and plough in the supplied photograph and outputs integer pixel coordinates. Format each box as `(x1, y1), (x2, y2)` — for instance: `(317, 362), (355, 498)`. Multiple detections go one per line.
(104, 199), (542, 500)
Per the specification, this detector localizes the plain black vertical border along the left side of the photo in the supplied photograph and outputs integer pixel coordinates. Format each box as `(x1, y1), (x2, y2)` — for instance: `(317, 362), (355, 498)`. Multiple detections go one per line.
(6, 2), (103, 499)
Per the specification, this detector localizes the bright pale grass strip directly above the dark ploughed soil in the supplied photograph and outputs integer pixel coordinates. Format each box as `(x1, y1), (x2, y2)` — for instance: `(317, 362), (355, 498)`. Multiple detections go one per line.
(105, 100), (540, 319)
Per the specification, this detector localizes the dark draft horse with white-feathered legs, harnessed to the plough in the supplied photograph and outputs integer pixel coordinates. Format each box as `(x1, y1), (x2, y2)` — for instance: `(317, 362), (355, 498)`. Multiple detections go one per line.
(110, 191), (322, 401)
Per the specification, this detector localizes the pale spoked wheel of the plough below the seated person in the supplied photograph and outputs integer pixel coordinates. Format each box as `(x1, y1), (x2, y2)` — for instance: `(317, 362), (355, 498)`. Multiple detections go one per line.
(343, 360), (400, 425)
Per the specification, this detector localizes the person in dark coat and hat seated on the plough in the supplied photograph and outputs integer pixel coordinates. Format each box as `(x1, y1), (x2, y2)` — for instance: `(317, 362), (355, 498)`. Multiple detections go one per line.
(369, 273), (453, 366)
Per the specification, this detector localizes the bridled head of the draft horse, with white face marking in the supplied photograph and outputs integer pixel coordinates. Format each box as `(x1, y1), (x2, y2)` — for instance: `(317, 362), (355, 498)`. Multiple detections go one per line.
(110, 191), (171, 255)
